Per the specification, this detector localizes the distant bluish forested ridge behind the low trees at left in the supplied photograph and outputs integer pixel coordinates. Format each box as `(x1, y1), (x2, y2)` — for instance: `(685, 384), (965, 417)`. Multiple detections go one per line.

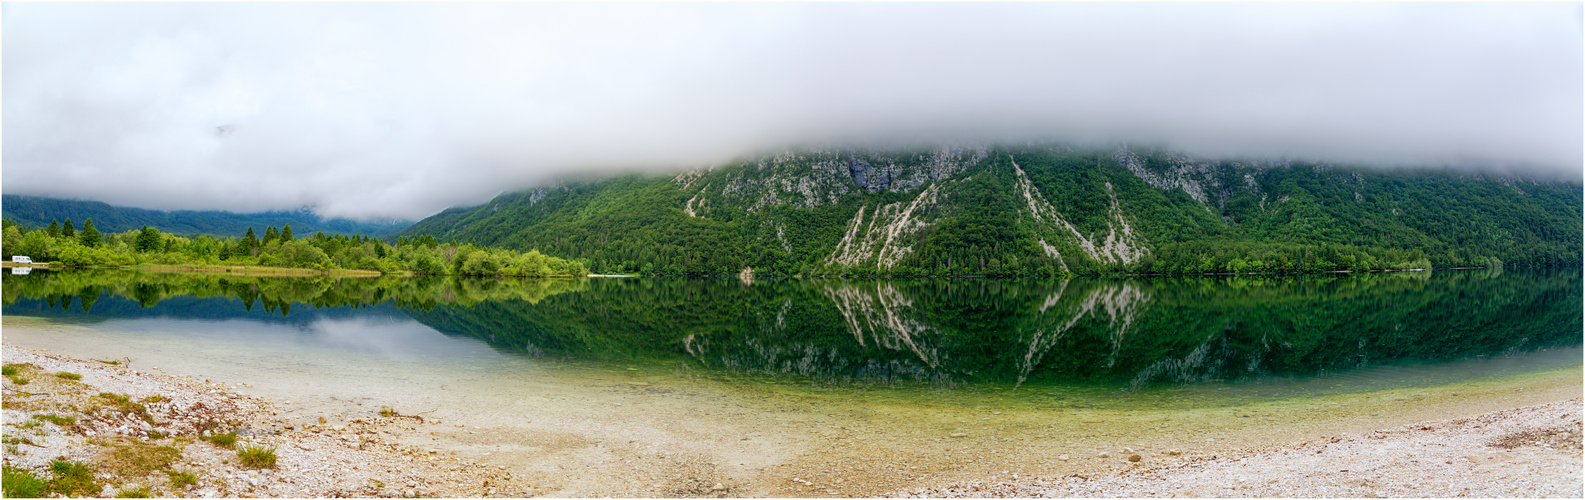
(0, 195), (412, 237)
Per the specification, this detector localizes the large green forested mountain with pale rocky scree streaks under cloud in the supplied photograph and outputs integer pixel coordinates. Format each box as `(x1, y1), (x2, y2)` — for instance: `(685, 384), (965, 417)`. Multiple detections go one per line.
(401, 144), (1582, 275)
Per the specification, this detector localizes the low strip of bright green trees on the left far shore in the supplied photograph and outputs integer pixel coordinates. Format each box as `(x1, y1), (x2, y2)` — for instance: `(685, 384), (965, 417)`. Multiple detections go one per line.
(0, 219), (588, 278)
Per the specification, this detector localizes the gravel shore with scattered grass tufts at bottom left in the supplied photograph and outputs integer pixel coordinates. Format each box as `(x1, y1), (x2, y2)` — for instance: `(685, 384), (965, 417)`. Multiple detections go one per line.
(3, 346), (512, 497)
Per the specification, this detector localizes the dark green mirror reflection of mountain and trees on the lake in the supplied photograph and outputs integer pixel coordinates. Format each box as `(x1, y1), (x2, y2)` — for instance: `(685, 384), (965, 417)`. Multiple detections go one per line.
(0, 268), (1582, 387)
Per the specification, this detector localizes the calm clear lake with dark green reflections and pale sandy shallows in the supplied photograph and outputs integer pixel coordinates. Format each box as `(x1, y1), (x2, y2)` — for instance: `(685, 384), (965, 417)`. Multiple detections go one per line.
(0, 268), (1582, 495)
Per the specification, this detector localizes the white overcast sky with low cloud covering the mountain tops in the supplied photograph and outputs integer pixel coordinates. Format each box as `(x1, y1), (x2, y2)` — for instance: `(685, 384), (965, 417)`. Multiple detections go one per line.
(0, 3), (1585, 219)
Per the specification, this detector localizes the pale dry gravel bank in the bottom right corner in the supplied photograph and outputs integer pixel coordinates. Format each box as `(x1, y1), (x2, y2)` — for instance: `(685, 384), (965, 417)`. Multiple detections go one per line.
(902, 398), (1585, 498)
